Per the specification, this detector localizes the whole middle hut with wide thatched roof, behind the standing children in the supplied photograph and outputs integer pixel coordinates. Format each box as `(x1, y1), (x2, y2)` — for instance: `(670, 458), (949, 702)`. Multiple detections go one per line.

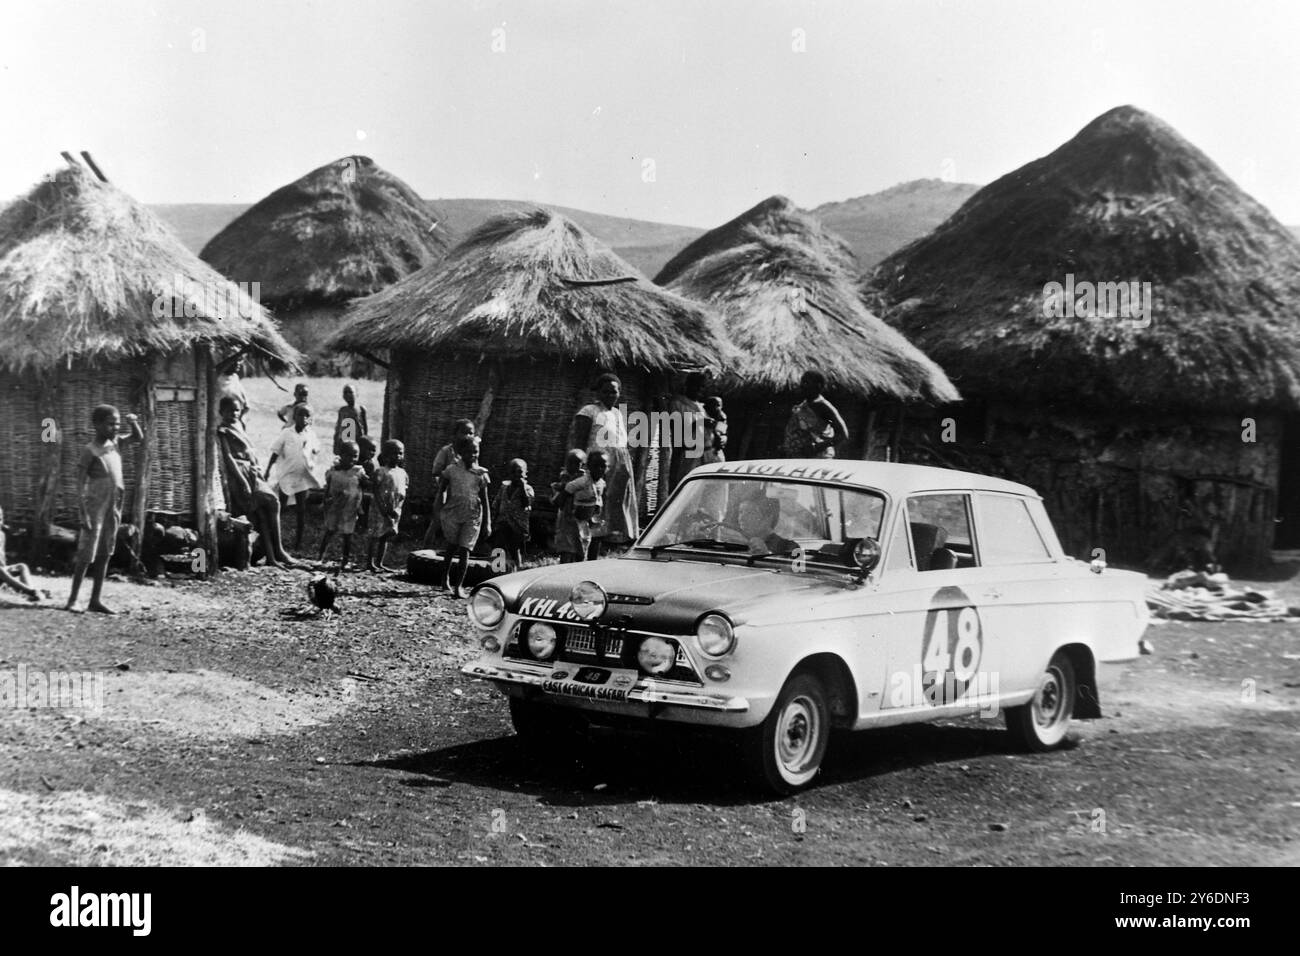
(329, 208), (727, 512)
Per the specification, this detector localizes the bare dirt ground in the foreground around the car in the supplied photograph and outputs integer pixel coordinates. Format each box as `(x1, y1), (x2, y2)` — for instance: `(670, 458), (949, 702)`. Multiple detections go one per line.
(0, 546), (1300, 865)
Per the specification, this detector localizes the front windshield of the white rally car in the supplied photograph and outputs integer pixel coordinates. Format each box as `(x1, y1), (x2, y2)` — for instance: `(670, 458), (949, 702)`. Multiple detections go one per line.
(637, 475), (885, 567)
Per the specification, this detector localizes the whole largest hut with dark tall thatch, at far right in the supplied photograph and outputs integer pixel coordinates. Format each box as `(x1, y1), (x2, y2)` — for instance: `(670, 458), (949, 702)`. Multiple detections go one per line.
(865, 107), (1300, 563)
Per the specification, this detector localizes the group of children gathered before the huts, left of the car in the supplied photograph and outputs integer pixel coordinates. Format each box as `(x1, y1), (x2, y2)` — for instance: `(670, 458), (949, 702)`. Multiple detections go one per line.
(0, 382), (727, 614)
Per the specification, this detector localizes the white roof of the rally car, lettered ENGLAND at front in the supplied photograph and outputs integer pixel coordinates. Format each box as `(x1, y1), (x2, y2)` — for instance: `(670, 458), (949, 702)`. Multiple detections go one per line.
(690, 458), (1039, 498)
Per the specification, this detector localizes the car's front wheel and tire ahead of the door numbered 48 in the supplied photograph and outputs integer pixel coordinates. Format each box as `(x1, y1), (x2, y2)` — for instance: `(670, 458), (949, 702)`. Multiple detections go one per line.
(745, 672), (831, 796)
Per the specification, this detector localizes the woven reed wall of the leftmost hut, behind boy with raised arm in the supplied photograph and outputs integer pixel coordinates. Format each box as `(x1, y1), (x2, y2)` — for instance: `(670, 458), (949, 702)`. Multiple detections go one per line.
(0, 352), (199, 527)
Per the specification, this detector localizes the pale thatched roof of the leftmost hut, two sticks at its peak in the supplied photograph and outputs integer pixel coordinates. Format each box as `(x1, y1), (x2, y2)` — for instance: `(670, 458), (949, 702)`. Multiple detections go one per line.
(0, 168), (299, 373)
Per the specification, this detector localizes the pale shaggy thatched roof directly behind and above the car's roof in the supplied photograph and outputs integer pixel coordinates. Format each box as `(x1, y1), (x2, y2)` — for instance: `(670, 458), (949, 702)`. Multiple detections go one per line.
(668, 226), (959, 402)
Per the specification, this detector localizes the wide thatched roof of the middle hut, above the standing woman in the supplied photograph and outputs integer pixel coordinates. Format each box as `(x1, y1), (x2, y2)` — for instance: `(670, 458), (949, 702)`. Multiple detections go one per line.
(326, 209), (727, 369)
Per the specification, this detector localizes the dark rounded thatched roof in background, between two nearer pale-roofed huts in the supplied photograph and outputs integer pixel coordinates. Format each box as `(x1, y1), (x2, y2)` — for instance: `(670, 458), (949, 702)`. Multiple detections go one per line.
(200, 156), (449, 310)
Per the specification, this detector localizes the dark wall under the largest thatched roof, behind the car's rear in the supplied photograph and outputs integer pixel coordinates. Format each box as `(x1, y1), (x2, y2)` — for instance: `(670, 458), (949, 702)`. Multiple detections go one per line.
(904, 405), (1282, 571)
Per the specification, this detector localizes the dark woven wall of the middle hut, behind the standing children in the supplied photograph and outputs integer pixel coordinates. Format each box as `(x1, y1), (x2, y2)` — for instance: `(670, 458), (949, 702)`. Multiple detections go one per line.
(387, 354), (658, 501)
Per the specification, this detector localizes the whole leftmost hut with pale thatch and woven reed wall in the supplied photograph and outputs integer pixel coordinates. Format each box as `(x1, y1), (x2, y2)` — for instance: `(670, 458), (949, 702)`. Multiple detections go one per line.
(0, 168), (298, 561)
